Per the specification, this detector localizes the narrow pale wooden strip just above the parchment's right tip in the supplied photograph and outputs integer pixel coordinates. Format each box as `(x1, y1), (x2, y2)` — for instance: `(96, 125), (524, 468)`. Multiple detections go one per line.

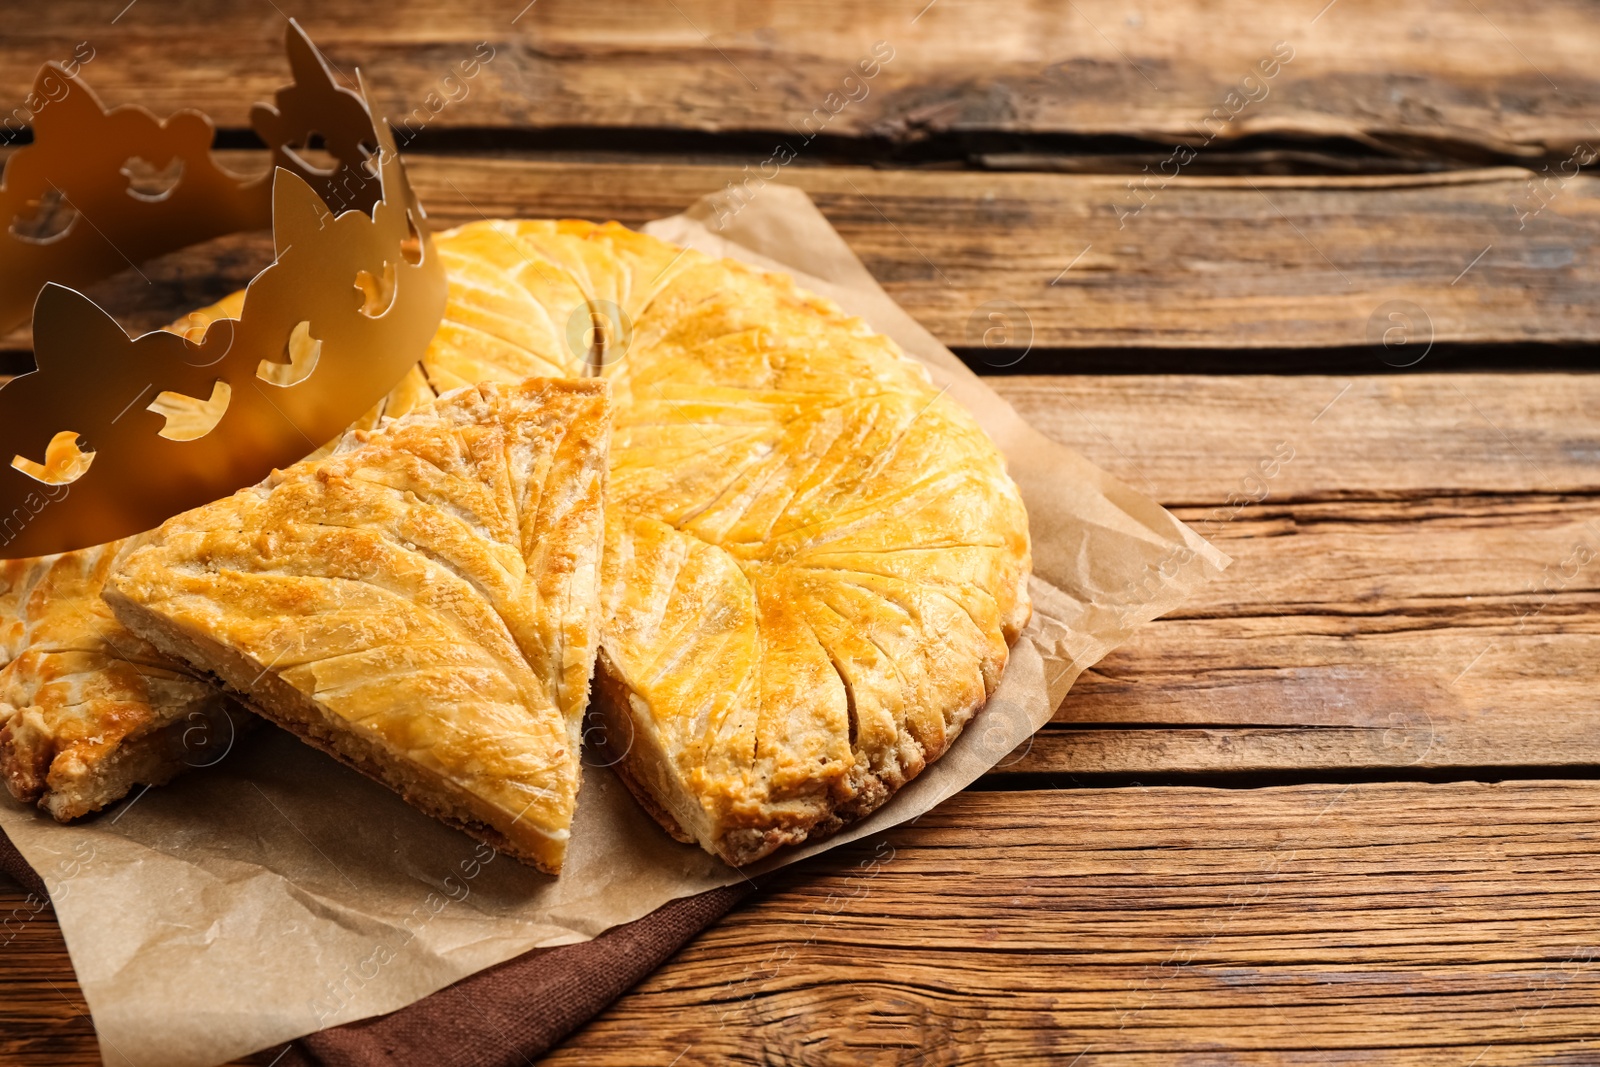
(989, 374), (1600, 502)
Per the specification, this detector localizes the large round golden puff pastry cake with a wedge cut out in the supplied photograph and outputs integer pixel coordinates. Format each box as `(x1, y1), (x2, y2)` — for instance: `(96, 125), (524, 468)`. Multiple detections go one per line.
(424, 221), (1030, 864)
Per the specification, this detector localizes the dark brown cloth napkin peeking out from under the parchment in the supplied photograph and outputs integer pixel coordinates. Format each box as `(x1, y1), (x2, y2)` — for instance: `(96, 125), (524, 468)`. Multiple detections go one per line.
(0, 832), (750, 1067)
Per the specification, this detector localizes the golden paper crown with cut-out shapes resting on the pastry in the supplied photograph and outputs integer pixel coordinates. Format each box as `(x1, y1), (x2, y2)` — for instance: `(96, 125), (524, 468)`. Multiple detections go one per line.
(0, 21), (446, 558)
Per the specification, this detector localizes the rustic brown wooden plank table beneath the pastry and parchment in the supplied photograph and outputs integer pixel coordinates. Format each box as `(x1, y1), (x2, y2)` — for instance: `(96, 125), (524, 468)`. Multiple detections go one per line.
(0, 0), (1600, 1067)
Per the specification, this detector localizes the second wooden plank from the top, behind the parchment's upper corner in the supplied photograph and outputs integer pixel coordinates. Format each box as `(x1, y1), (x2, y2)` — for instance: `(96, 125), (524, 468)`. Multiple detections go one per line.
(6, 157), (1600, 355)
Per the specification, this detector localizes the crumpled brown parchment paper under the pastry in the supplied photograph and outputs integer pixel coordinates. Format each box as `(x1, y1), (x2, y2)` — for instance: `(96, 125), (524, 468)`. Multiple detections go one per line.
(0, 184), (1227, 1067)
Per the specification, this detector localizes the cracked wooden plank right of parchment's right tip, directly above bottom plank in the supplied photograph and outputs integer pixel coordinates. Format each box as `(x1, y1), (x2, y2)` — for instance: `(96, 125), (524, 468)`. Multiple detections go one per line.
(1003, 498), (1600, 779)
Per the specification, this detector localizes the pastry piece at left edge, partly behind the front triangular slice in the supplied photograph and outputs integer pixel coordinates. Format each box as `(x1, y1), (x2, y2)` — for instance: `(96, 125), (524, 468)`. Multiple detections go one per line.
(0, 542), (244, 822)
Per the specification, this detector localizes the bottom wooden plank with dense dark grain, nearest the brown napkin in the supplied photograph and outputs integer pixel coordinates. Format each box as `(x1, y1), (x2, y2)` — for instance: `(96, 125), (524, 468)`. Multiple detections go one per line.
(544, 782), (1600, 1067)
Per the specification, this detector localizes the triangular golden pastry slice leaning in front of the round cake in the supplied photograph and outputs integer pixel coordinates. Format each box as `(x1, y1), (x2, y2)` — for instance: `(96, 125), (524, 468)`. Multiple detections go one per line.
(106, 379), (610, 873)
